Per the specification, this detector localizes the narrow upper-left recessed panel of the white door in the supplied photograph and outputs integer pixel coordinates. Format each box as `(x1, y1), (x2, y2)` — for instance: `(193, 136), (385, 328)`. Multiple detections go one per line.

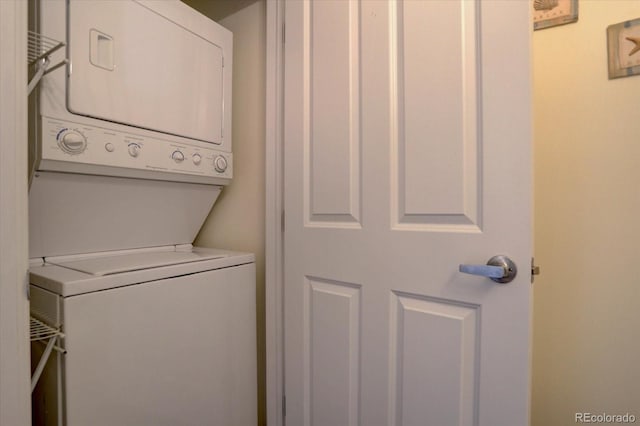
(303, 1), (361, 227)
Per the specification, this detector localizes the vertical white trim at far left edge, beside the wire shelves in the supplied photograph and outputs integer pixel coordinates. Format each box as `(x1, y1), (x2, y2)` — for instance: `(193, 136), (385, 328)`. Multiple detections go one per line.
(0, 0), (31, 426)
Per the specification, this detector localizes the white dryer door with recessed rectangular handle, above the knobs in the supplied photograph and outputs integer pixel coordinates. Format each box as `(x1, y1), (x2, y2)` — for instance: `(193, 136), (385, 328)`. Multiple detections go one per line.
(67, 0), (231, 144)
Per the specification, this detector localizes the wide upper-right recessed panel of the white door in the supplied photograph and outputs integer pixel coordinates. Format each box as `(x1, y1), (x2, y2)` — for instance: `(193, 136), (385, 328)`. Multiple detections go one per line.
(390, 0), (480, 229)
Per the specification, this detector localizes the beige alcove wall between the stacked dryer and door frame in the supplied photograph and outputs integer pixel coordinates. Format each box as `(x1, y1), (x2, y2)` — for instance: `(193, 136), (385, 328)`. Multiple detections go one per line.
(188, 0), (266, 424)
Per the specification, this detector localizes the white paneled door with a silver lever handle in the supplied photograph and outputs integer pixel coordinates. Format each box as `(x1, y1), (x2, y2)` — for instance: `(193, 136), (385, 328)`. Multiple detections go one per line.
(284, 0), (532, 426)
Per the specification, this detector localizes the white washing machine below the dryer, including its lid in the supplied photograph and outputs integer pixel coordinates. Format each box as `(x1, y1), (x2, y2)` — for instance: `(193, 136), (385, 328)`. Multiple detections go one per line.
(30, 245), (257, 426)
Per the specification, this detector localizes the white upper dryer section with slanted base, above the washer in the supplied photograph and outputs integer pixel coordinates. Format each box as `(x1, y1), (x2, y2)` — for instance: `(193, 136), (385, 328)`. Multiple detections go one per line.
(29, 0), (233, 257)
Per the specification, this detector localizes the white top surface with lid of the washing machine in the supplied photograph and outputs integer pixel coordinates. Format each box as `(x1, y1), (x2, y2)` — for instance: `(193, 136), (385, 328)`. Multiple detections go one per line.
(29, 245), (255, 297)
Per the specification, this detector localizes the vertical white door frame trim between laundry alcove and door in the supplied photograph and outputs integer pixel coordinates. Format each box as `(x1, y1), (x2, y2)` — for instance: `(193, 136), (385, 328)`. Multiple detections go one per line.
(265, 0), (284, 426)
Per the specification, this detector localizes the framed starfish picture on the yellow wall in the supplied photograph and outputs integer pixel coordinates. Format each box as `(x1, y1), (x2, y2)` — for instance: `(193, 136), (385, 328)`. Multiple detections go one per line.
(607, 18), (640, 79)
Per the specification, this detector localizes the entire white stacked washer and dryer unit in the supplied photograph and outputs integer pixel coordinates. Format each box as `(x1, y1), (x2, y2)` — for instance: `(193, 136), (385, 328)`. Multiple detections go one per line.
(29, 0), (257, 426)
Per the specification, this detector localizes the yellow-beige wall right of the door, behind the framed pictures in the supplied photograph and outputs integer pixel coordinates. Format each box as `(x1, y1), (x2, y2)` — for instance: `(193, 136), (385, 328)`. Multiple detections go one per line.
(532, 0), (640, 426)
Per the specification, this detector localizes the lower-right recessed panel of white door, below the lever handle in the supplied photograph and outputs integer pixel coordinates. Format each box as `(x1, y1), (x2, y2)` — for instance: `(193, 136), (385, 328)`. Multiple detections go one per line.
(390, 294), (479, 425)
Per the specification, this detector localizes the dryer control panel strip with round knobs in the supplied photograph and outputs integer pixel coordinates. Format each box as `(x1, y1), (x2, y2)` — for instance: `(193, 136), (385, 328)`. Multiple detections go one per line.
(41, 117), (232, 179)
